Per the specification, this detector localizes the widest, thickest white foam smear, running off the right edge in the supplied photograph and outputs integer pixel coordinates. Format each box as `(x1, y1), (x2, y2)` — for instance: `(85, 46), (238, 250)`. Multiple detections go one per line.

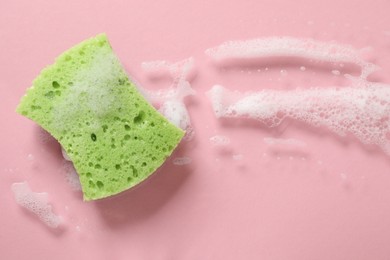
(207, 81), (390, 155)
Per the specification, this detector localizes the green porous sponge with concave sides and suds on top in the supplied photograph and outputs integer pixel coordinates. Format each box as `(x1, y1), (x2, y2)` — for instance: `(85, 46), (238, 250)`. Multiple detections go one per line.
(17, 34), (184, 200)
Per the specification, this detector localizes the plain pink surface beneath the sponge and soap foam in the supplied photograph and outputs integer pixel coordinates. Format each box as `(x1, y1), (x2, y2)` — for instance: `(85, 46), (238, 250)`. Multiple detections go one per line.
(0, 0), (390, 260)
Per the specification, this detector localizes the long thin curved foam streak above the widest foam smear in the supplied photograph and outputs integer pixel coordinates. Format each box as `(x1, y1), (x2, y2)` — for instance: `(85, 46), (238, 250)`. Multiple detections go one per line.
(206, 37), (378, 79)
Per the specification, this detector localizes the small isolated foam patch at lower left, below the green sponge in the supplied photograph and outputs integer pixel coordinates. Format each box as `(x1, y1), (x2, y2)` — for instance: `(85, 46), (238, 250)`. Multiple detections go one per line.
(11, 182), (62, 228)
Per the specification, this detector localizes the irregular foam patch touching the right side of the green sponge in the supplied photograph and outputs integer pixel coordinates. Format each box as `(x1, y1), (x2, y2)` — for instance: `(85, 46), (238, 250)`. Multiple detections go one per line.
(141, 58), (196, 140)
